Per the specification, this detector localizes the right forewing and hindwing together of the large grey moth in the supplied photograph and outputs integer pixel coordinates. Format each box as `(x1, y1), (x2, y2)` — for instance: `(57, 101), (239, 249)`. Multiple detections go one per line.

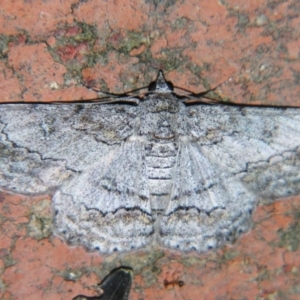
(161, 105), (300, 251)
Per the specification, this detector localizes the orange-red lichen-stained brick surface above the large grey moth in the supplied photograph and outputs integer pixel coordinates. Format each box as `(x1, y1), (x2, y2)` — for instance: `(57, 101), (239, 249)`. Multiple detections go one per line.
(0, 0), (300, 106)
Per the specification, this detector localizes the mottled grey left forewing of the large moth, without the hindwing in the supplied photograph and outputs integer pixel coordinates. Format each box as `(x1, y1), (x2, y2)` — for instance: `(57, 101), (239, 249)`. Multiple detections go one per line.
(0, 104), (137, 193)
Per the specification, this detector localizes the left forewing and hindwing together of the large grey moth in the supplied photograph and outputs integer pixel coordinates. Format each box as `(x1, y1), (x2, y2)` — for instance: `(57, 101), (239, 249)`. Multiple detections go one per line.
(0, 104), (152, 252)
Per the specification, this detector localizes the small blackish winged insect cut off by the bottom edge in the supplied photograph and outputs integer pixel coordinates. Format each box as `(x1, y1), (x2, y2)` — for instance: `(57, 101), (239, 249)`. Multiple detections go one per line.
(73, 267), (133, 300)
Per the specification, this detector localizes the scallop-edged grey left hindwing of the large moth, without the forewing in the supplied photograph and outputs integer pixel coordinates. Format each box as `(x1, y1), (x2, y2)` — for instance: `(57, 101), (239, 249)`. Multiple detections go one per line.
(53, 137), (153, 252)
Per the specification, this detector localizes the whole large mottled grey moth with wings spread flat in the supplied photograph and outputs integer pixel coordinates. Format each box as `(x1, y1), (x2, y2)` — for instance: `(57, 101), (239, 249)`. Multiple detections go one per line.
(0, 72), (300, 253)
